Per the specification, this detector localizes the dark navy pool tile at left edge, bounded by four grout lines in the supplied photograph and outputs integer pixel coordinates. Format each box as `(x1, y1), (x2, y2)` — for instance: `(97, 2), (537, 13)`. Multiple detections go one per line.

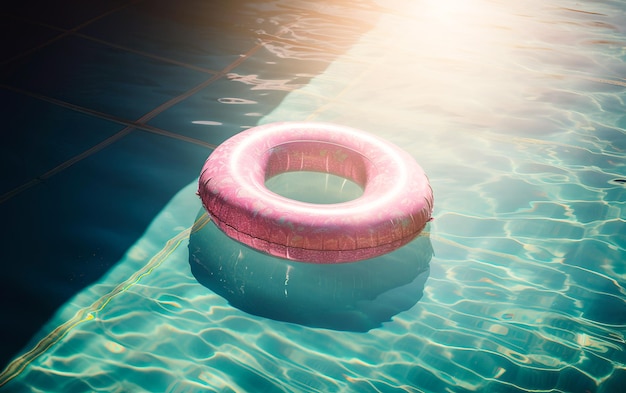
(0, 36), (208, 120)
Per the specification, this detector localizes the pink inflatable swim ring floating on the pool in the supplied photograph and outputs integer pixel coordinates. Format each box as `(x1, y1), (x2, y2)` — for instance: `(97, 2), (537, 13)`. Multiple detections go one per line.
(198, 122), (433, 263)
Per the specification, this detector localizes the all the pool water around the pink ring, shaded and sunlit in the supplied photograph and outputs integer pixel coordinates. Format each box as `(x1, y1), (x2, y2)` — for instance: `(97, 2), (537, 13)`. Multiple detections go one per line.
(0, 0), (626, 392)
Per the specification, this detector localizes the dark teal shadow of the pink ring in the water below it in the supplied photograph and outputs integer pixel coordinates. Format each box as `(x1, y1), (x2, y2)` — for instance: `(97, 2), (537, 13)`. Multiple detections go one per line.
(189, 211), (433, 332)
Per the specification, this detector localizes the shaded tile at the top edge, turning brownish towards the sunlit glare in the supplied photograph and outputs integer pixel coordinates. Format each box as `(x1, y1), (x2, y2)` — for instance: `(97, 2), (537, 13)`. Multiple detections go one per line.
(80, 0), (276, 71)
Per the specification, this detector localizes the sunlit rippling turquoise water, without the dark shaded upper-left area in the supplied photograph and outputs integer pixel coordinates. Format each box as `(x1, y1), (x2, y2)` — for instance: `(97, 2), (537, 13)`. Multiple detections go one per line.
(0, 0), (626, 392)
